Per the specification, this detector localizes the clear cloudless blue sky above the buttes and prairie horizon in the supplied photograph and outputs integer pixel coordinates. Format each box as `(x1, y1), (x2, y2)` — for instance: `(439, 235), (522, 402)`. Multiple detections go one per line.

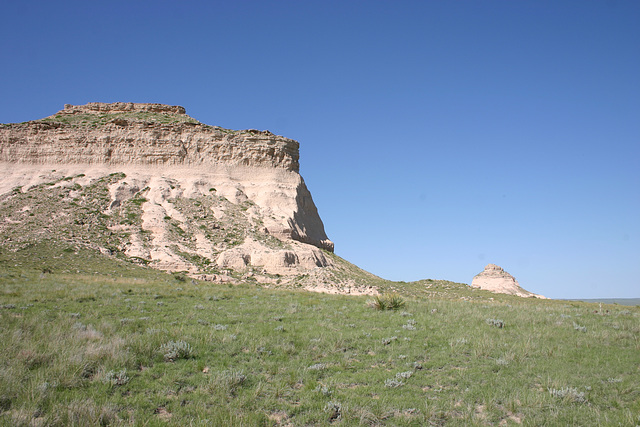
(0, 0), (640, 298)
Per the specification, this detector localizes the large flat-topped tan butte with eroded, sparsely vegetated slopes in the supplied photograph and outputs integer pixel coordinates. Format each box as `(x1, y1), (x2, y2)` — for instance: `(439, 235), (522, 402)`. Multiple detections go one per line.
(0, 103), (350, 290)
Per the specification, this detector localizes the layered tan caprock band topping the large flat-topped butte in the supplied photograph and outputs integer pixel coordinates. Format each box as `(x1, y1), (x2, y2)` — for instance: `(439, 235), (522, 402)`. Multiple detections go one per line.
(0, 102), (299, 172)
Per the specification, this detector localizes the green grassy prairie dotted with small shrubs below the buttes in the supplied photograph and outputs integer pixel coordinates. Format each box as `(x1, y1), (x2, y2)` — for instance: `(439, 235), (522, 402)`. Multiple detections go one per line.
(0, 247), (640, 426)
